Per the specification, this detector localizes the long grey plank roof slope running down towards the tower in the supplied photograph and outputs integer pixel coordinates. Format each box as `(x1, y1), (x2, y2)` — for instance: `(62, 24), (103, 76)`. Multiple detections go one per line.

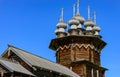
(2, 45), (79, 77)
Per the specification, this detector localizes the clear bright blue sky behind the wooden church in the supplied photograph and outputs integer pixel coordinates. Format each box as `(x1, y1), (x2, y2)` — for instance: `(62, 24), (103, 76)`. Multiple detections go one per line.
(0, 0), (120, 77)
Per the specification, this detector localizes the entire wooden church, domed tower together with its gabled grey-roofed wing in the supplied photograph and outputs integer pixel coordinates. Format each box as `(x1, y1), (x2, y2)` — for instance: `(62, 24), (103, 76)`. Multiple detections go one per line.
(0, 0), (107, 77)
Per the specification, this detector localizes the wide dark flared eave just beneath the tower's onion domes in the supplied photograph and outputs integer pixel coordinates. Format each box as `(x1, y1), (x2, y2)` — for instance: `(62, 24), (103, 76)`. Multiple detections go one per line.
(49, 35), (107, 50)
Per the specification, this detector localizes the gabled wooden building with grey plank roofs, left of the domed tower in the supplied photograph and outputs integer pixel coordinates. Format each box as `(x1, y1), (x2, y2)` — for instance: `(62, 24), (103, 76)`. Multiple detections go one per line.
(0, 45), (79, 77)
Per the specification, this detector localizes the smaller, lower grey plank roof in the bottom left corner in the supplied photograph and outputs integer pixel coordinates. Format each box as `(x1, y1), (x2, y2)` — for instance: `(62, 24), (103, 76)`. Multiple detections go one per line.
(0, 58), (35, 76)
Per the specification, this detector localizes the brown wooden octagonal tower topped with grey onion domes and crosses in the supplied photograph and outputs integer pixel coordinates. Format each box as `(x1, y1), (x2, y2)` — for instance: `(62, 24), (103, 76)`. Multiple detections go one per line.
(49, 0), (107, 77)
